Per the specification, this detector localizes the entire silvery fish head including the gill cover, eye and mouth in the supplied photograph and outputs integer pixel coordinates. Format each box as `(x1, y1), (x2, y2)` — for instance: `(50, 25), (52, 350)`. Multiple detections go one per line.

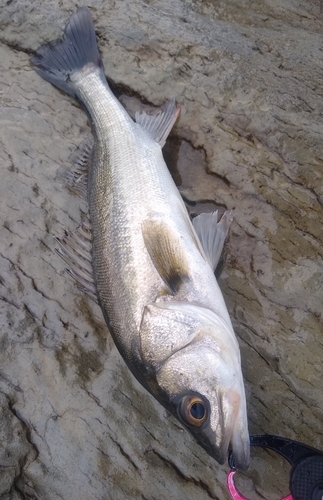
(142, 302), (250, 470)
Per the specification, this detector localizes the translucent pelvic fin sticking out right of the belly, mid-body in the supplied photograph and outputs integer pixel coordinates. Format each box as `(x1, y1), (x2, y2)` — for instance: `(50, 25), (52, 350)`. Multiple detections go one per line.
(193, 210), (233, 271)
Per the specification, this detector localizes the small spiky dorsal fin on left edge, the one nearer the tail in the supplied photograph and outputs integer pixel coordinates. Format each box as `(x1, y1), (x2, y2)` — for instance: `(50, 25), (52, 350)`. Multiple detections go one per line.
(57, 136), (94, 199)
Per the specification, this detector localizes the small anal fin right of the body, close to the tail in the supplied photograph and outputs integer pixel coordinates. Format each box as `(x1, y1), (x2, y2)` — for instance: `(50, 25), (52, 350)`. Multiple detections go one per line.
(135, 98), (181, 147)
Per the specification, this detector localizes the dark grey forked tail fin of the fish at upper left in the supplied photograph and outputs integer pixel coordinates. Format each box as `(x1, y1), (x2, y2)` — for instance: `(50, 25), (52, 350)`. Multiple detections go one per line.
(30, 7), (105, 97)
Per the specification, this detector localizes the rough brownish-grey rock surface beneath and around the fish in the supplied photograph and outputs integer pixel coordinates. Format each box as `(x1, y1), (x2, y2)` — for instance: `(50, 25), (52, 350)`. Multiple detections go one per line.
(0, 0), (323, 500)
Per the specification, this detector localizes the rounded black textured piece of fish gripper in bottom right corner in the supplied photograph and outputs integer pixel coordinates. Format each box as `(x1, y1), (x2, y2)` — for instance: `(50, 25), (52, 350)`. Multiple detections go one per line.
(290, 456), (323, 500)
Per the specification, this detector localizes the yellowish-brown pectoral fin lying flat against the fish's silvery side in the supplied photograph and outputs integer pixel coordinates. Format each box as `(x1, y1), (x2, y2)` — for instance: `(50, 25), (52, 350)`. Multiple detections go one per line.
(142, 219), (188, 294)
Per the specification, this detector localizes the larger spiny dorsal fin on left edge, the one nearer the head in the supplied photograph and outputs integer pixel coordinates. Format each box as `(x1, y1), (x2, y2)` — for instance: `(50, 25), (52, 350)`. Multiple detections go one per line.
(55, 213), (97, 302)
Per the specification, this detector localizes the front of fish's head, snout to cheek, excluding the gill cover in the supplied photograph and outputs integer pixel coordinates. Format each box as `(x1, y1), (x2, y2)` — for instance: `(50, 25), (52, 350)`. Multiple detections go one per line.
(157, 341), (249, 469)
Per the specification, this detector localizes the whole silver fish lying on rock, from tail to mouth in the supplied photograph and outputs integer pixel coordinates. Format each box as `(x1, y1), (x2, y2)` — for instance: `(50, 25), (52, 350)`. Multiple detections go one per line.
(30, 7), (250, 469)
